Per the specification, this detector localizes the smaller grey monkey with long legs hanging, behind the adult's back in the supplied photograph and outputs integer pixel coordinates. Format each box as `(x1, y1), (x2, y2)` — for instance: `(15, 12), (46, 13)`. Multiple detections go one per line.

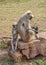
(12, 25), (18, 51)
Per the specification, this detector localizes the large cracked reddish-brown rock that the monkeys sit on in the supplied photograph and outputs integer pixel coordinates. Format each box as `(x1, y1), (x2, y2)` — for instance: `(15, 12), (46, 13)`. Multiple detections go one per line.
(8, 34), (46, 62)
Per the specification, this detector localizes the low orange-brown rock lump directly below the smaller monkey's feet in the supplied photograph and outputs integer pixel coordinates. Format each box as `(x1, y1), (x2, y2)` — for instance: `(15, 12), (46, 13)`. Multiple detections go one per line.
(10, 51), (22, 62)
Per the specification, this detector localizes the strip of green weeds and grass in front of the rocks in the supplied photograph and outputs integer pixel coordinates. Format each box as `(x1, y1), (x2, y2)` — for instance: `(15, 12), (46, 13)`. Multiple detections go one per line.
(0, 58), (46, 65)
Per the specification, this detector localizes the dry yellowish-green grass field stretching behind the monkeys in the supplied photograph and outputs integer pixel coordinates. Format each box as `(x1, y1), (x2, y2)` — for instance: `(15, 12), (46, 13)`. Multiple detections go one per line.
(0, 0), (46, 36)
